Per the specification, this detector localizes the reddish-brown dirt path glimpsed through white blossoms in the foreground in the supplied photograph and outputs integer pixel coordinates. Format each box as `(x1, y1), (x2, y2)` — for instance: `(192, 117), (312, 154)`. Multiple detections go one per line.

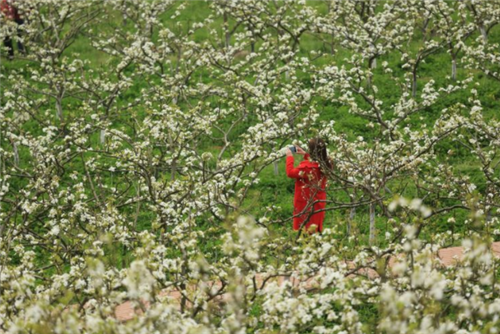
(115, 241), (500, 321)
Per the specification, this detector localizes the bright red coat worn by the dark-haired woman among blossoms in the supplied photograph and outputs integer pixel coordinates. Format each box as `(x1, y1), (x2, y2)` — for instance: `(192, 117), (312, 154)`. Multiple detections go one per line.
(286, 154), (326, 231)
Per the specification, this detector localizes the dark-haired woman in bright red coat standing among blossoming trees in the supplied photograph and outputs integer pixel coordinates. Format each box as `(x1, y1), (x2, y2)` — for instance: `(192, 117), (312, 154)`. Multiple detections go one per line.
(286, 138), (333, 232)
